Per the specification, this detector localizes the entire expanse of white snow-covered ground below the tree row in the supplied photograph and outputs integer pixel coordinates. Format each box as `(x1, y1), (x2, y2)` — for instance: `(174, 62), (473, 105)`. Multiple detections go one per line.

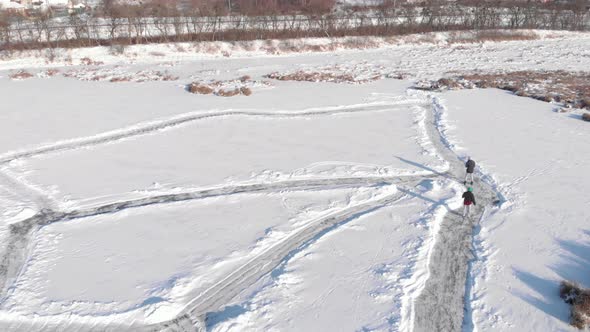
(0, 32), (590, 331)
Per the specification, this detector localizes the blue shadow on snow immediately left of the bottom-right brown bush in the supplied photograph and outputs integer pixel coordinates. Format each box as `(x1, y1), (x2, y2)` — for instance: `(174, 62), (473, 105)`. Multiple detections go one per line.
(513, 268), (569, 323)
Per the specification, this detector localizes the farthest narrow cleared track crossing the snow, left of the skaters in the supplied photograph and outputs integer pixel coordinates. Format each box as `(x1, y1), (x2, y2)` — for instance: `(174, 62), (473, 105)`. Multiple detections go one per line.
(0, 99), (424, 164)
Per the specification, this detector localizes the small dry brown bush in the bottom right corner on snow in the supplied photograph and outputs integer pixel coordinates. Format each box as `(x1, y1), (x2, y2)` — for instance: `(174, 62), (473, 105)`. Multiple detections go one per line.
(559, 281), (590, 330)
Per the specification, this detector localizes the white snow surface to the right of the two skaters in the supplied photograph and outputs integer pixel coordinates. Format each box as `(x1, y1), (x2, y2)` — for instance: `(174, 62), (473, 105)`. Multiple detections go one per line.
(442, 89), (590, 331)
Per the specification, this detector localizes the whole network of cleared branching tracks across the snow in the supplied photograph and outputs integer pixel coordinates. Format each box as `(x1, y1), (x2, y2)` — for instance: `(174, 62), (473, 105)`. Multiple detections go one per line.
(0, 91), (503, 331)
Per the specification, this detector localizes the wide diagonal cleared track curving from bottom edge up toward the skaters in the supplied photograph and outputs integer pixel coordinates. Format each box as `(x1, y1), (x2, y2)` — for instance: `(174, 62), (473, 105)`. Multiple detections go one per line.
(146, 188), (421, 332)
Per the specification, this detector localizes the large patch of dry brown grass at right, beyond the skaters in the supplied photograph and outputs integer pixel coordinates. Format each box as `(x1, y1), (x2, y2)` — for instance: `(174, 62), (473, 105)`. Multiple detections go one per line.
(415, 71), (590, 109)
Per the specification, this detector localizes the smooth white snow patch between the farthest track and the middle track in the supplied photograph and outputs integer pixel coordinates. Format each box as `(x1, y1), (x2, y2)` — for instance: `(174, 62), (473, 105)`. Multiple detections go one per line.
(1, 81), (436, 206)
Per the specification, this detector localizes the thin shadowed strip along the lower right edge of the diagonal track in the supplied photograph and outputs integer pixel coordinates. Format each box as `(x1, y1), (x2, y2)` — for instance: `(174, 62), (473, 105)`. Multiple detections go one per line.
(205, 195), (406, 331)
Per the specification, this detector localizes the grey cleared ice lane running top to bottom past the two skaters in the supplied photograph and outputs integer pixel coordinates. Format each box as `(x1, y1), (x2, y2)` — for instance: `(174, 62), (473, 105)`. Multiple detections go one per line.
(405, 97), (498, 332)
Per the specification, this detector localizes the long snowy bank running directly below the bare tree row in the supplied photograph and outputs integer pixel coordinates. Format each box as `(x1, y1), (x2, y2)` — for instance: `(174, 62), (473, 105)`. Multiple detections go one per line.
(0, 30), (588, 70)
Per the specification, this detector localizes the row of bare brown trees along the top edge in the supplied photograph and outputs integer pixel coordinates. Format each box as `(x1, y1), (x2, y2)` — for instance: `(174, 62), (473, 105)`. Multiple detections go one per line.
(0, 0), (590, 50)
